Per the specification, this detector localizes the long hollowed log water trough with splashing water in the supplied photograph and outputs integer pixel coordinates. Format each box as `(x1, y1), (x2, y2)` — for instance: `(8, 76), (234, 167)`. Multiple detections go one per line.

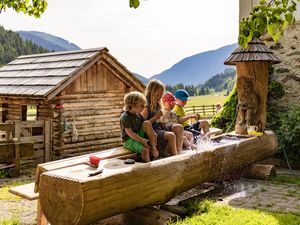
(39, 131), (278, 225)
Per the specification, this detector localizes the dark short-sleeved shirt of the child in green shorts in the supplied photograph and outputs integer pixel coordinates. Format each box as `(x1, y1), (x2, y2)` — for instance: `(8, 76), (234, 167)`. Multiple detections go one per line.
(120, 111), (144, 142)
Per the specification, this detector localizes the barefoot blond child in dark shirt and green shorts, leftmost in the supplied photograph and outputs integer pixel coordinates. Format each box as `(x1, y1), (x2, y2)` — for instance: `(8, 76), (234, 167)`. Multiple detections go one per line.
(120, 91), (159, 162)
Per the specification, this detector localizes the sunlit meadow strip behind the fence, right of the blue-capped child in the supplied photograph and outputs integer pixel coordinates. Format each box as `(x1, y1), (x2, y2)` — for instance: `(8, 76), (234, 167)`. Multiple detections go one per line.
(186, 95), (228, 107)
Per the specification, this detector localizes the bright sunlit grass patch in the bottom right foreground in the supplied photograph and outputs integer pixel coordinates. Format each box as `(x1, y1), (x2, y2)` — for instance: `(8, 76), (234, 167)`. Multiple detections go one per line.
(169, 201), (300, 225)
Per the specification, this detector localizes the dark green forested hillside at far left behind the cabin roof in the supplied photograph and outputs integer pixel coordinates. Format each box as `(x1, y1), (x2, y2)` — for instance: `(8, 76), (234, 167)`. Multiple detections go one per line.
(0, 26), (49, 66)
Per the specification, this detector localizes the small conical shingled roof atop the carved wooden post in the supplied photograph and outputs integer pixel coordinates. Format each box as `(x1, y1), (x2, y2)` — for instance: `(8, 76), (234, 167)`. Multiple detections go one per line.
(224, 40), (280, 65)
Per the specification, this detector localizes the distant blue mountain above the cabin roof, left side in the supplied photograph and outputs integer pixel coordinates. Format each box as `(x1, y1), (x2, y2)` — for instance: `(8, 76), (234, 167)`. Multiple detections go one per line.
(17, 31), (80, 52)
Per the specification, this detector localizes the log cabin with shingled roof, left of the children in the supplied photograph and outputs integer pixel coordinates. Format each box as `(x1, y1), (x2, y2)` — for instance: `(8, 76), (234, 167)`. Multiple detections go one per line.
(0, 48), (145, 163)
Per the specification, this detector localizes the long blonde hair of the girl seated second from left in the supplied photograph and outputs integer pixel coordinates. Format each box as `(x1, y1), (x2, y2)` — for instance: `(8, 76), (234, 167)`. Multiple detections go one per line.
(145, 80), (165, 112)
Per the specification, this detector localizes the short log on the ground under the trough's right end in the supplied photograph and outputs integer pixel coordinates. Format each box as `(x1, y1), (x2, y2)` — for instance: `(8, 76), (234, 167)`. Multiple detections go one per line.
(244, 164), (276, 180)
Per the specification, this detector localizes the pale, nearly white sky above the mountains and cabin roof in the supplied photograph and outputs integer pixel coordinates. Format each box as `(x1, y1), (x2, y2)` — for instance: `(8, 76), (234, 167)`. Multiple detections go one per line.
(0, 0), (239, 77)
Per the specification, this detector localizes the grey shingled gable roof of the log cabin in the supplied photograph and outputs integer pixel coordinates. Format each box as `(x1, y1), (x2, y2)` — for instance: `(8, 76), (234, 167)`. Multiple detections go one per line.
(0, 47), (145, 99)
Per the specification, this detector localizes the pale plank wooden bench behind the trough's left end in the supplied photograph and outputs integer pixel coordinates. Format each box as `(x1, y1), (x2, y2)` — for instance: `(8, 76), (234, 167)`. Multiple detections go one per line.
(9, 147), (136, 225)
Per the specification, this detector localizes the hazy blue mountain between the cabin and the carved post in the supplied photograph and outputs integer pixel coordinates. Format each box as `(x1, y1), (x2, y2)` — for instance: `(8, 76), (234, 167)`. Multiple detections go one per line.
(150, 44), (238, 85)
